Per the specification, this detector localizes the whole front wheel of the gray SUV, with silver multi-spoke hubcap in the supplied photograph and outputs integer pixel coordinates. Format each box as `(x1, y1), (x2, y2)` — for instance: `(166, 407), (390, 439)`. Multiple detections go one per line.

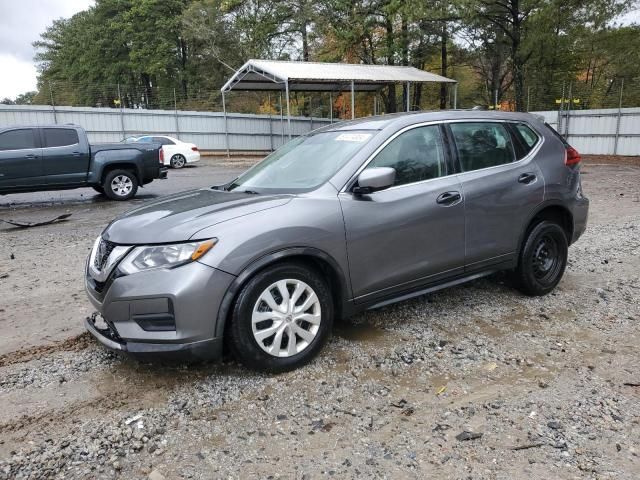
(229, 263), (334, 372)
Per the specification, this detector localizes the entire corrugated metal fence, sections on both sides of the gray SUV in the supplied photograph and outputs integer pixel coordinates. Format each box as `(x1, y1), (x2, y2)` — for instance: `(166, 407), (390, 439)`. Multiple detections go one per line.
(0, 105), (640, 155)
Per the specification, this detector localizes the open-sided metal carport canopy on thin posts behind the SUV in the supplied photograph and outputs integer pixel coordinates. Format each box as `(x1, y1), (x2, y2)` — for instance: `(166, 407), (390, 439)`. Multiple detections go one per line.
(220, 59), (458, 155)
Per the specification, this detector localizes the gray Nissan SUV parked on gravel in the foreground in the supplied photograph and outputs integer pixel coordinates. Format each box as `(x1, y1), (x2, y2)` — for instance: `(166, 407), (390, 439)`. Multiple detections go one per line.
(86, 111), (589, 372)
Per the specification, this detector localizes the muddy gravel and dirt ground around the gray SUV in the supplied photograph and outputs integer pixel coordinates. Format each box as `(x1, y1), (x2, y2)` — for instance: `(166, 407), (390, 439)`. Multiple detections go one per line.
(0, 160), (640, 480)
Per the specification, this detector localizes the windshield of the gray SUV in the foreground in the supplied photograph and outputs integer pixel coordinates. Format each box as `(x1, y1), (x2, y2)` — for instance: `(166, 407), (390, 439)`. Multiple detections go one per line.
(227, 130), (376, 193)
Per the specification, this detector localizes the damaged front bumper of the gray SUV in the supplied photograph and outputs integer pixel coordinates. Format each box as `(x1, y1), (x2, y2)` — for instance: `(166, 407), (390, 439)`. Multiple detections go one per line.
(85, 262), (235, 359)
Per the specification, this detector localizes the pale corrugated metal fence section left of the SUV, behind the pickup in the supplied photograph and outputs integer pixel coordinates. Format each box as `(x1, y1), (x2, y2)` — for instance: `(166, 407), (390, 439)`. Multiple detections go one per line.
(0, 105), (329, 151)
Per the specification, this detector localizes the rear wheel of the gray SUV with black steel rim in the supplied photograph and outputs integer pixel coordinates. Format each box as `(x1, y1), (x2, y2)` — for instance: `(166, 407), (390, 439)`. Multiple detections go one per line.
(513, 221), (569, 296)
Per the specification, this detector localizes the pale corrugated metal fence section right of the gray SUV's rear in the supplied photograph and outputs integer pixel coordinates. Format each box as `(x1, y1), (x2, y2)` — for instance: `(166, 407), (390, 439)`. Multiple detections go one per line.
(531, 108), (640, 155)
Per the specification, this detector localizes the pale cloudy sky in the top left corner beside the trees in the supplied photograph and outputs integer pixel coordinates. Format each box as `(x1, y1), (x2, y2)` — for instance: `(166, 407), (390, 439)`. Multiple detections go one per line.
(0, 0), (93, 99)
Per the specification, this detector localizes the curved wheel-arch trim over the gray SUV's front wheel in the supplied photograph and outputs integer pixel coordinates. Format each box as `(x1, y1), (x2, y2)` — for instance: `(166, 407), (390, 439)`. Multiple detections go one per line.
(215, 247), (350, 338)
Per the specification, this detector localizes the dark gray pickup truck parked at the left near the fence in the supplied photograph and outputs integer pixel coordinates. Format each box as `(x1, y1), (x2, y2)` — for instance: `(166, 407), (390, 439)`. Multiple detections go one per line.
(0, 125), (167, 200)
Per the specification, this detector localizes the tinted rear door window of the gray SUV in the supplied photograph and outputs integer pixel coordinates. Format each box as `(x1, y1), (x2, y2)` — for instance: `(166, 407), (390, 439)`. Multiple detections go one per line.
(449, 122), (515, 172)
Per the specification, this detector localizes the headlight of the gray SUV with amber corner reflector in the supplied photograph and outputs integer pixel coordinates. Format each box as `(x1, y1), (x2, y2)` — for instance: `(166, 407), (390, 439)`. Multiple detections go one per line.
(120, 238), (218, 275)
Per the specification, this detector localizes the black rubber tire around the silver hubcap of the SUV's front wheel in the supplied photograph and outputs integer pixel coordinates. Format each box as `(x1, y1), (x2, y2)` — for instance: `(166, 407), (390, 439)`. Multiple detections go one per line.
(227, 263), (334, 373)
